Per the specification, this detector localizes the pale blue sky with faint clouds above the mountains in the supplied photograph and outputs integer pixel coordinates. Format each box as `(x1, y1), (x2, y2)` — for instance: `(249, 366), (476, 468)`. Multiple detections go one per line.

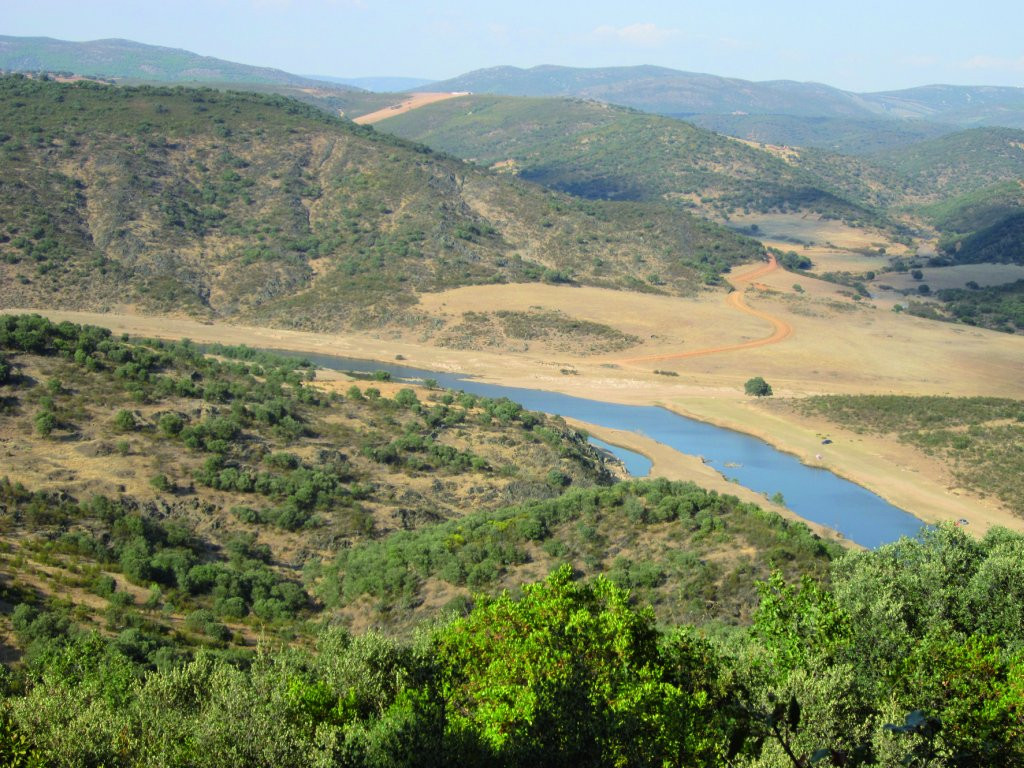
(0, 0), (1024, 92)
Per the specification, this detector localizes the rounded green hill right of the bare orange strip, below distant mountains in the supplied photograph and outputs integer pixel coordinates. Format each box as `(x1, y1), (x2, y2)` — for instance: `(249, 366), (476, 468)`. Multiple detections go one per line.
(378, 96), (881, 225)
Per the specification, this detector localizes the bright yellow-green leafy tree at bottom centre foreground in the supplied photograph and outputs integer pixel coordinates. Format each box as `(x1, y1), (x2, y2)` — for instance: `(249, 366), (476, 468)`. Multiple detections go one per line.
(436, 565), (724, 766)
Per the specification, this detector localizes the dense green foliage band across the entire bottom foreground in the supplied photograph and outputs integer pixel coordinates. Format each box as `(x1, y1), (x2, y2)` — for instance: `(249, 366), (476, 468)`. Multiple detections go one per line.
(0, 527), (1024, 768)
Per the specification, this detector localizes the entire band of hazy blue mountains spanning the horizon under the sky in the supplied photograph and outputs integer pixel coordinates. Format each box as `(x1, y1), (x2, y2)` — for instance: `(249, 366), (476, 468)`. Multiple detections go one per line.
(0, 36), (1024, 129)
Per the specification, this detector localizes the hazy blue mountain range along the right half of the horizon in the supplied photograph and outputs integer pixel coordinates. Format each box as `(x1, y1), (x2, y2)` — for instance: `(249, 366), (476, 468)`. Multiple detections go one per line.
(430, 66), (1024, 128)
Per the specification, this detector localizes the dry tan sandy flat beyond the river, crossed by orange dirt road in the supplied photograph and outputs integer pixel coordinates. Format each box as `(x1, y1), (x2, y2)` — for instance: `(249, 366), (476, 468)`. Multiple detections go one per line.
(16, 265), (1024, 531)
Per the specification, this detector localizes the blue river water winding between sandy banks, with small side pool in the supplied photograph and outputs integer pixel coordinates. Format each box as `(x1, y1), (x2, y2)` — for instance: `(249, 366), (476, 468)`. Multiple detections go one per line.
(269, 350), (924, 548)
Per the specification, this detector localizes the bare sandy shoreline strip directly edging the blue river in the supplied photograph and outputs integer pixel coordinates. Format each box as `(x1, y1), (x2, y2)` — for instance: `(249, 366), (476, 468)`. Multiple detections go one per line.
(9, 308), (1024, 536)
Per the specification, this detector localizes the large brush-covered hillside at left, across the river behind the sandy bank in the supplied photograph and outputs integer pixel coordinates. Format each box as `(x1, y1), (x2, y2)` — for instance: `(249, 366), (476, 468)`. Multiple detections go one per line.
(0, 76), (759, 329)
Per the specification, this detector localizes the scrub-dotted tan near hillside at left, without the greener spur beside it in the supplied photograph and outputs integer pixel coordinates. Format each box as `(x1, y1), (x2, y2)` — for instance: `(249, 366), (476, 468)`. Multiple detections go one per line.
(0, 315), (612, 645)
